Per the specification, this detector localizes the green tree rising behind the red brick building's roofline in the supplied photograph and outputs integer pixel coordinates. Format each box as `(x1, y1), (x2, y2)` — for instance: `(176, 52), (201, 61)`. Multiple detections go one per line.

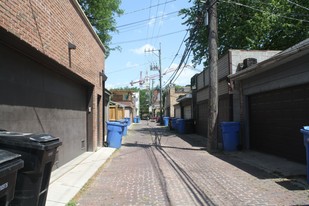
(78, 0), (123, 56)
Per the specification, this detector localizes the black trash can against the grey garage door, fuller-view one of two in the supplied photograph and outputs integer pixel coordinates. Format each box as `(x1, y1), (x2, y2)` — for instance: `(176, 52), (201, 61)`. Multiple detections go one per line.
(0, 132), (61, 206)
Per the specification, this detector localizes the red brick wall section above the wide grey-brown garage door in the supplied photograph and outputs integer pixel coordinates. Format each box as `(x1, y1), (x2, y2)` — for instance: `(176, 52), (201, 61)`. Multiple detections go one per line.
(0, 0), (104, 86)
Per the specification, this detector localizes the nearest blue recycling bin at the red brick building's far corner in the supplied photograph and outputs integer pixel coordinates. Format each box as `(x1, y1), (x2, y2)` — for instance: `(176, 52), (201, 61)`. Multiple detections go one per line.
(106, 122), (125, 149)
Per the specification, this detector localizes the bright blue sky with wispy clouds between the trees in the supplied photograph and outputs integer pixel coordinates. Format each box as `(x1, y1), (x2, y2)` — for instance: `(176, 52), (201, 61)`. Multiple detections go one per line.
(105, 0), (202, 89)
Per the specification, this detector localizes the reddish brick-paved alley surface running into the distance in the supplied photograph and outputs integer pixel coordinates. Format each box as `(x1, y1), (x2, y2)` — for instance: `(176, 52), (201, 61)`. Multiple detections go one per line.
(77, 121), (309, 206)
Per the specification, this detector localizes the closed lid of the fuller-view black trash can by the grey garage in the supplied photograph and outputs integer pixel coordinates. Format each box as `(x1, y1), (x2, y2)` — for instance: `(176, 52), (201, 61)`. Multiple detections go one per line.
(0, 132), (61, 150)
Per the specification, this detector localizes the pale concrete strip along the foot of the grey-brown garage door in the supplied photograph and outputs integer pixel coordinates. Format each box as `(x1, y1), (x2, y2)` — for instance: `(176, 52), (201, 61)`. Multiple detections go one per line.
(46, 147), (116, 206)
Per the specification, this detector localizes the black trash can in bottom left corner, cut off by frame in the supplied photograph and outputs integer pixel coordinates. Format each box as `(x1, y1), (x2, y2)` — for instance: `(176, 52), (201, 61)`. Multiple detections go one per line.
(0, 149), (24, 206)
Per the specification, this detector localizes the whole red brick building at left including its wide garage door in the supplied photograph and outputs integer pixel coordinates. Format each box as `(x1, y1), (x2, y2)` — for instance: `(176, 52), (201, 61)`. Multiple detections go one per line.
(0, 0), (106, 167)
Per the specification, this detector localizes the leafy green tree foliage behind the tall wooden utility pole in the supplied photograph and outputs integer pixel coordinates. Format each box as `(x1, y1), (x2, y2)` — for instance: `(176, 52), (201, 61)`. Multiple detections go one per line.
(180, 0), (309, 64)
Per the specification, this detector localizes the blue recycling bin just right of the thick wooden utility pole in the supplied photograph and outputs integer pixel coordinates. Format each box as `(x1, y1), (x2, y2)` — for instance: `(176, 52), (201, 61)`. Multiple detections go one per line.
(221, 122), (240, 151)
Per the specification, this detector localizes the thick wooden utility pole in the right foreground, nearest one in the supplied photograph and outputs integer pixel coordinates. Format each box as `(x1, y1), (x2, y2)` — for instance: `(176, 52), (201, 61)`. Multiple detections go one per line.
(207, 0), (218, 151)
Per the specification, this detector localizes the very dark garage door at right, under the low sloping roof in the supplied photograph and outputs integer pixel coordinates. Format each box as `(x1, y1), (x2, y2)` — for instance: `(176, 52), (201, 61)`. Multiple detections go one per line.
(249, 84), (309, 163)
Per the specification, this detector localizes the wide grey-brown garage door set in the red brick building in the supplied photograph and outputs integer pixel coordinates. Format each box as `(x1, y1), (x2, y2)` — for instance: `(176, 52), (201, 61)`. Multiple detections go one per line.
(0, 44), (88, 167)
